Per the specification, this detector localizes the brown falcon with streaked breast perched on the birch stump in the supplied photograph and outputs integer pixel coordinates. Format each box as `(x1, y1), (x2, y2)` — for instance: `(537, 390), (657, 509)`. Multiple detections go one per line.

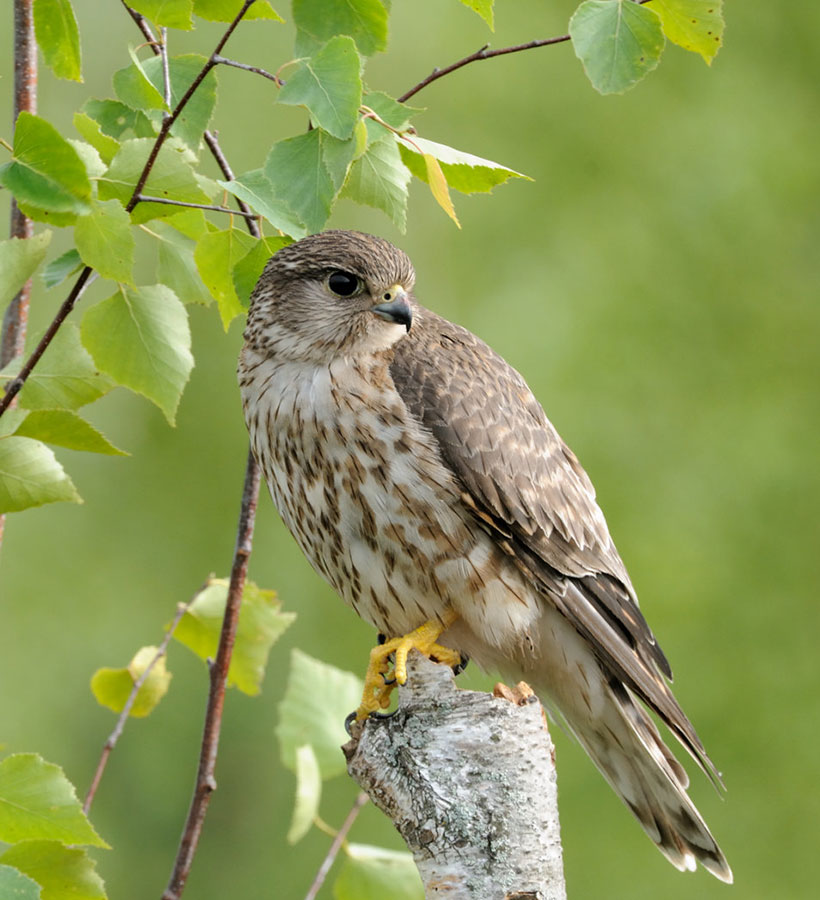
(239, 231), (732, 882)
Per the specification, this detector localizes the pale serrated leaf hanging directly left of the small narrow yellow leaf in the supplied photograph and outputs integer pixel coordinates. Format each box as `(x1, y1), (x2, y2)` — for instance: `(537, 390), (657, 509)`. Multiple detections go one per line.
(342, 138), (410, 232)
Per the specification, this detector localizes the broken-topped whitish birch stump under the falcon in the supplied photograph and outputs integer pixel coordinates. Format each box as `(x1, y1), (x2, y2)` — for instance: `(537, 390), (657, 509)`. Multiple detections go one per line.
(343, 651), (566, 900)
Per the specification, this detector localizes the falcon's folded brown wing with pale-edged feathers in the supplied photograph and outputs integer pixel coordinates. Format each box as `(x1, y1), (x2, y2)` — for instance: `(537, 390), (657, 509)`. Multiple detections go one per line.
(390, 309), (711, 770)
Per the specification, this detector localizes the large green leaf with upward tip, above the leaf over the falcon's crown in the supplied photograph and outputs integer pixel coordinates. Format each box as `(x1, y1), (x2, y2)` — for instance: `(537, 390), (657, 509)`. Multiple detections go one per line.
(279, 35), (362, 140)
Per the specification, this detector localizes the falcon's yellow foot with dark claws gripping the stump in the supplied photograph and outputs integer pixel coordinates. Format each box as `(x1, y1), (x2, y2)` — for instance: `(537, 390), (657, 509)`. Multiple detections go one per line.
(356, 610), (463, 721)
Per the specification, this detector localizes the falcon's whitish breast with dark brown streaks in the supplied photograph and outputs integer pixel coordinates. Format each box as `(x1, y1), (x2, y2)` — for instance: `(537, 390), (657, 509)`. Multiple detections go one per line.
(240, 351), (484, 634)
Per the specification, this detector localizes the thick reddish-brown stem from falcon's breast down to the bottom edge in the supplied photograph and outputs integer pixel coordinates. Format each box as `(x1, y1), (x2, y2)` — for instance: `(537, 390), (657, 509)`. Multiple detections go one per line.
(162, 449), (259, 900)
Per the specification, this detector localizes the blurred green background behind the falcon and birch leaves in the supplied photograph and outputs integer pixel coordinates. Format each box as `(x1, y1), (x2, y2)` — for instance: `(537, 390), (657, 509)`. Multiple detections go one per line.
(0, 0), (820, 900)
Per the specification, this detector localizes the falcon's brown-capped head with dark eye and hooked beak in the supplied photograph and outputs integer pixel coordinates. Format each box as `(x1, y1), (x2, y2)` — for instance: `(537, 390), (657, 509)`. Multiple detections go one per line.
(245, 231), (416, 363)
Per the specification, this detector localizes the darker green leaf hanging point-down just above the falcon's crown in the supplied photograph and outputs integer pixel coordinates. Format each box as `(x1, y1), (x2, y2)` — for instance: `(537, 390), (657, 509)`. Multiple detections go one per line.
(264, 128), (336, 237)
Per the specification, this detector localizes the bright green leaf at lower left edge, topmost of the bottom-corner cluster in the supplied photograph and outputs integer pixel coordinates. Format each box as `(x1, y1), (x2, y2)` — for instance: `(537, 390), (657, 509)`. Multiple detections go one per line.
(0, 753), (108, 847)
